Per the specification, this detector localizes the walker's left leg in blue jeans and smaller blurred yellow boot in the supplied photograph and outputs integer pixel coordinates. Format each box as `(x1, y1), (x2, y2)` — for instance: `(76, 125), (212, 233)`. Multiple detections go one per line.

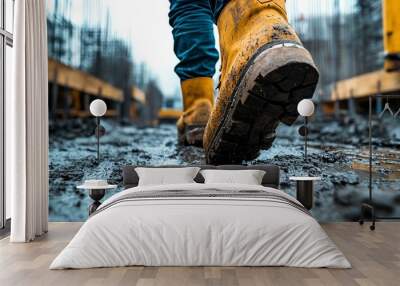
(169, 0), (218, 146)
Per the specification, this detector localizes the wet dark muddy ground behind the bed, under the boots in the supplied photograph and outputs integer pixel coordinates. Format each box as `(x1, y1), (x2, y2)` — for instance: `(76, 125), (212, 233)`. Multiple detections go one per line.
(49, 117), (400, 222)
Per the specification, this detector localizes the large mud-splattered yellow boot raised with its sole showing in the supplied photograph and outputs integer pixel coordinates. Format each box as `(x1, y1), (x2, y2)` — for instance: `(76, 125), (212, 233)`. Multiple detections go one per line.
(203, 0), (319, 164)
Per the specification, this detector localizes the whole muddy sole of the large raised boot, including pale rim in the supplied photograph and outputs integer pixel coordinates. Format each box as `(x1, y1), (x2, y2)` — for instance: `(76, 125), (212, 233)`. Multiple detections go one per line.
(206, 43), (319, 164)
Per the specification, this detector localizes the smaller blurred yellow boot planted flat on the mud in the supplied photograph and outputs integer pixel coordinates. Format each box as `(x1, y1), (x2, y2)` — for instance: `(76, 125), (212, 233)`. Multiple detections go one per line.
(176, 77), (214, 147)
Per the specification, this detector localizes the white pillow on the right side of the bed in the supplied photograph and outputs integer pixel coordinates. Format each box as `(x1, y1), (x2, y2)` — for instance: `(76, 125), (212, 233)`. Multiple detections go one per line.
(200, 170), (265, 185)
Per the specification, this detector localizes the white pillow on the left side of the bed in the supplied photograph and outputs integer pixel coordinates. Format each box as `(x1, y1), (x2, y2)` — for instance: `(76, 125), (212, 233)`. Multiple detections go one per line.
(135, 167), (200, 186)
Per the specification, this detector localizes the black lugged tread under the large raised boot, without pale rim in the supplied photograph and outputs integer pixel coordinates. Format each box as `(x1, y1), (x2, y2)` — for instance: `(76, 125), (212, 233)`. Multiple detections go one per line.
(207, 52), (318, 164)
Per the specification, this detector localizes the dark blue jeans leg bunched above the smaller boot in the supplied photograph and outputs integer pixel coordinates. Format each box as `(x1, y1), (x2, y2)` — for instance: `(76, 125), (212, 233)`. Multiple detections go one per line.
(168, 0), (229, 81)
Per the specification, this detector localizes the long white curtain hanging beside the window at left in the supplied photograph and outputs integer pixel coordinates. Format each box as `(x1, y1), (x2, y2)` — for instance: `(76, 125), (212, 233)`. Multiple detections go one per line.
(6, 0), (48, 242)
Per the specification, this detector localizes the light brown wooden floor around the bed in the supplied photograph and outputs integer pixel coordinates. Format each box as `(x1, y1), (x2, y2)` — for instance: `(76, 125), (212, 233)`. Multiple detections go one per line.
(0, 223), (400, 286)
